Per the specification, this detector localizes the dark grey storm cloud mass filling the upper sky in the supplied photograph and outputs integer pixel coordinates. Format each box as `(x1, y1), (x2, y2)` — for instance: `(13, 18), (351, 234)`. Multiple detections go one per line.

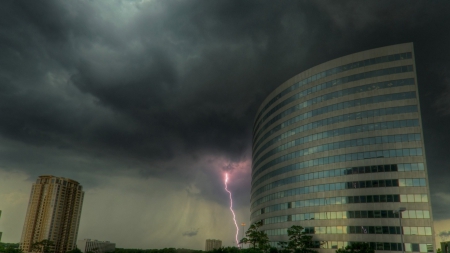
(0, 1), (450, 219)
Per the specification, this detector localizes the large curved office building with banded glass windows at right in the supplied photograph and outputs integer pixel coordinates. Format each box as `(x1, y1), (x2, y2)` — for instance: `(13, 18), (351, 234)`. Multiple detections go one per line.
(251, 43), (434, 252)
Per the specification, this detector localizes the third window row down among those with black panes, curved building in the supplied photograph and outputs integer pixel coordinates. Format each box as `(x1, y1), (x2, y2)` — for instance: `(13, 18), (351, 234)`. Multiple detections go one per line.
(251, 194), (428, 218)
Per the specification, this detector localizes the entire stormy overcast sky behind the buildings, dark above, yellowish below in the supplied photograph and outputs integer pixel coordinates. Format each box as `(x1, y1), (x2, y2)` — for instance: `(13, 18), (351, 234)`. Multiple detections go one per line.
(0, 0), (450, 249)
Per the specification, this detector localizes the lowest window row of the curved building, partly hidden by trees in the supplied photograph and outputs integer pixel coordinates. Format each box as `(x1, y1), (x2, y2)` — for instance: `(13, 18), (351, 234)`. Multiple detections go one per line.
(269, 241), (434, 252)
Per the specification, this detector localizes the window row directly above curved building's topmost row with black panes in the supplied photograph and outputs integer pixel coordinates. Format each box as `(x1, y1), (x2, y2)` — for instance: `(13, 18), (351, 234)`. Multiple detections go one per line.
(253, 145), (423, 187)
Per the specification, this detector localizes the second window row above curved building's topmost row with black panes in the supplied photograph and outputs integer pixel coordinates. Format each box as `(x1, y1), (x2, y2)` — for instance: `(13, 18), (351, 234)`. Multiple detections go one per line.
(254, 131), (421, 175)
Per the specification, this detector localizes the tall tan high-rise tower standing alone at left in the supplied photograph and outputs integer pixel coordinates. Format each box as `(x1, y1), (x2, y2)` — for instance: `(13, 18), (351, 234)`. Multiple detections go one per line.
(20, 175), (84, 253)
